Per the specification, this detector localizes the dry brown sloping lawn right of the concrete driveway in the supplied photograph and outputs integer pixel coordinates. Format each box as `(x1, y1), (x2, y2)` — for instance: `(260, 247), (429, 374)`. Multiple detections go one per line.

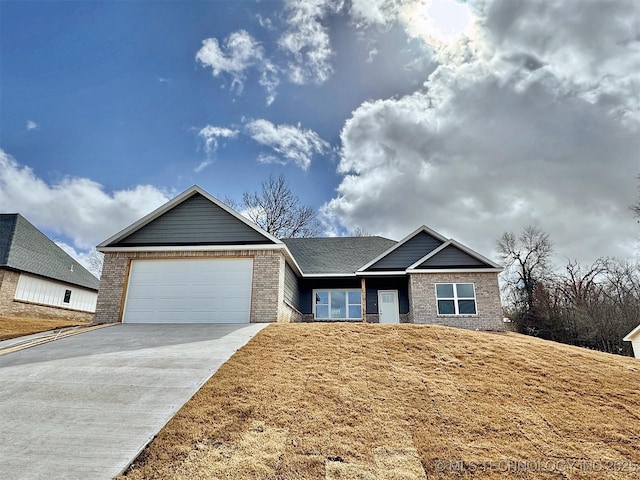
(122, 324), (640, 480)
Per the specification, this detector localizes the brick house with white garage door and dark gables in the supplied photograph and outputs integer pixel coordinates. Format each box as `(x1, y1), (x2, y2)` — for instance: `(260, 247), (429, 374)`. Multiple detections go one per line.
(95, 186), (503, 330)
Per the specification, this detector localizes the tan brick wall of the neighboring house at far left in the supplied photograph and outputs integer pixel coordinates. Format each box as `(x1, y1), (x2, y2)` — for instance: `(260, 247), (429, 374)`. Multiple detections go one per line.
(0, 269), (93, 322)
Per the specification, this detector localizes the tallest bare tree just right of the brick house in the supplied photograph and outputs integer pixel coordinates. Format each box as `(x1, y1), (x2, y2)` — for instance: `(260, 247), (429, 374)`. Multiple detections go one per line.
(497, 226), (553, 334)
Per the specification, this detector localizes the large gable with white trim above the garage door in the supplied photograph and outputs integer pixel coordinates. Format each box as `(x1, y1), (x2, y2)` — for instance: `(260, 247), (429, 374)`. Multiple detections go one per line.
(97, 185), (282, 250)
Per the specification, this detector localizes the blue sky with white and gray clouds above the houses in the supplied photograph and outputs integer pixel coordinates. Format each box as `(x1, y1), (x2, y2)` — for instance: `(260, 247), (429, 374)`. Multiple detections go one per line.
(0, 0), (640, 272)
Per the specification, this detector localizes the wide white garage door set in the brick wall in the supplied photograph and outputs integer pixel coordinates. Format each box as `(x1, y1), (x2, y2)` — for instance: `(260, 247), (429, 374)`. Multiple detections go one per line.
(122, 258), (253, 323)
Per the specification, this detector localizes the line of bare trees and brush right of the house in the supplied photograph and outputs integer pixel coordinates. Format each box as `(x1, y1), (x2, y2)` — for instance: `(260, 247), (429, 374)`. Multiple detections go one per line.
(497, 227), (640, 355)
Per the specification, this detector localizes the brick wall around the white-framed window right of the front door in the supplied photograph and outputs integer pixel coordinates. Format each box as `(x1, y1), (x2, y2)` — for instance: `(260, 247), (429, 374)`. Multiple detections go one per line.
(409, 272), (504, 331)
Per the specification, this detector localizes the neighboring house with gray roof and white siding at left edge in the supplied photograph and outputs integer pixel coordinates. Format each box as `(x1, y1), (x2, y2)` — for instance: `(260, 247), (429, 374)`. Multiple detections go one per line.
(0, 213), (99, 322)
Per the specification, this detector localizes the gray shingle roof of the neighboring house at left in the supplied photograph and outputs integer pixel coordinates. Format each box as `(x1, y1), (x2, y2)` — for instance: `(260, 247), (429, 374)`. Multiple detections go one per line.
(0, 213), (100, 290)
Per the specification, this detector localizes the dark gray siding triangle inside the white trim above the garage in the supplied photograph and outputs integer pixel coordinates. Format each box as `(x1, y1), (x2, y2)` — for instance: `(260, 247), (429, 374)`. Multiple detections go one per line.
(108, 192), (274, 247)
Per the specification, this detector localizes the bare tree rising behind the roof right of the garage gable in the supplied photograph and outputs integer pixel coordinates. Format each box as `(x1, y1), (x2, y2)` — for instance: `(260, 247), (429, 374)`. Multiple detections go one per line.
(242, 175), (322, 238)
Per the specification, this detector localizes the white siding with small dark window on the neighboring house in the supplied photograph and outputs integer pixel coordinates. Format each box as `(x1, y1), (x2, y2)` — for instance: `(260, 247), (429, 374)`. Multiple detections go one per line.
(14, 273), (98, 312)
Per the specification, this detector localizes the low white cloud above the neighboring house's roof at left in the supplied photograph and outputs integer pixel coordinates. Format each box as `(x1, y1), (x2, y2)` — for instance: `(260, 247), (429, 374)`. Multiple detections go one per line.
(0, 150), (168, 251)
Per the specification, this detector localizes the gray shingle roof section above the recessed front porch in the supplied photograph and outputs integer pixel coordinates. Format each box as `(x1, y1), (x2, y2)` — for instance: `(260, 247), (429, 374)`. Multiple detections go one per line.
(282, 237), (396, 274)
